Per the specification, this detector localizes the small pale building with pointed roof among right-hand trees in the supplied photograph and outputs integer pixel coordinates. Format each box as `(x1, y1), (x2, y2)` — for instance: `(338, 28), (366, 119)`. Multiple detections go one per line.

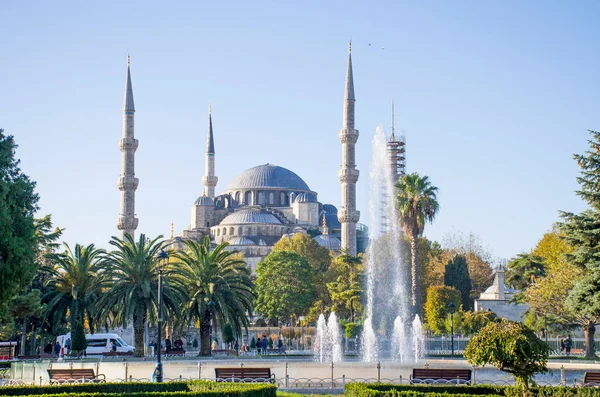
(475, 265), (529, 322)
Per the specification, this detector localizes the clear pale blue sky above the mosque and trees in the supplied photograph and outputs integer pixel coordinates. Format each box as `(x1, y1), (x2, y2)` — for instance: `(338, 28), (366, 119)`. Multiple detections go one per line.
(0, 0), (600, 258)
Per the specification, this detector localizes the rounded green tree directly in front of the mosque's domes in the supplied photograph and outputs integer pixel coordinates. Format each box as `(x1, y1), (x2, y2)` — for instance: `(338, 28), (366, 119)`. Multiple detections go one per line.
(255, 252), (314, 321)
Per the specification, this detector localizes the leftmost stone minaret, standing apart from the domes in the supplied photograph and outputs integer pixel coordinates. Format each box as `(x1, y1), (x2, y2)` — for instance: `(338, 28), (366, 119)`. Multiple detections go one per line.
(117, 55), (139, 239)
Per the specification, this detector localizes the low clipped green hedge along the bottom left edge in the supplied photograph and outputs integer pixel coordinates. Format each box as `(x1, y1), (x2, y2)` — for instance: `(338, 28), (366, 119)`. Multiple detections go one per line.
(0, 381), (276, 397)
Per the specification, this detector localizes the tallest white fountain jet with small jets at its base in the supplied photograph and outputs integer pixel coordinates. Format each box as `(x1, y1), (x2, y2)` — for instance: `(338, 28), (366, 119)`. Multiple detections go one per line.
(362, 127), (424, 363)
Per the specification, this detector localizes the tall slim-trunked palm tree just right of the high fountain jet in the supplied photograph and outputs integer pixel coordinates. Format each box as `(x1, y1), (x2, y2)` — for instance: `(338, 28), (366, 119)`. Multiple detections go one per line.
(396, 173), (440, 314)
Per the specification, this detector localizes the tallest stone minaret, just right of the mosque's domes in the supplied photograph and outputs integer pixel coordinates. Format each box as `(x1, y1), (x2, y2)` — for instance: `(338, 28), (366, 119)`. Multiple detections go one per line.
(338, 42), (360, 255)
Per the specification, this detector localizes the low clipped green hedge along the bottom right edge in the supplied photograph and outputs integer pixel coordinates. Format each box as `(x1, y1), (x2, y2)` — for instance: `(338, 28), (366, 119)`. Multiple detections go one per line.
(344, 383), (600, 397)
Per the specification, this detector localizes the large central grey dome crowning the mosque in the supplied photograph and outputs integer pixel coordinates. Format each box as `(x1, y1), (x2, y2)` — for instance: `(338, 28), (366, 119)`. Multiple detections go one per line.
(227, 164), (310, 191)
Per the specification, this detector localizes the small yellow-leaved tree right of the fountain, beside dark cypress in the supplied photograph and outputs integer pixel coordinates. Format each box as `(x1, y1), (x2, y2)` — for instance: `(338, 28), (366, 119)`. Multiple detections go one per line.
(425, 286), (461, 335)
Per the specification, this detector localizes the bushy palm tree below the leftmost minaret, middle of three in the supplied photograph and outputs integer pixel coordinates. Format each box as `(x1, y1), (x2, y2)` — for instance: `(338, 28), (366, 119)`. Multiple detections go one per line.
(95, 234), (183, 356)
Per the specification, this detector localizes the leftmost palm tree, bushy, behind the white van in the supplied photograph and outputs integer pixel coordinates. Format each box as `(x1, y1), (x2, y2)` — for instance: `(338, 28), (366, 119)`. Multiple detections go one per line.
(42, 243), (104, 332)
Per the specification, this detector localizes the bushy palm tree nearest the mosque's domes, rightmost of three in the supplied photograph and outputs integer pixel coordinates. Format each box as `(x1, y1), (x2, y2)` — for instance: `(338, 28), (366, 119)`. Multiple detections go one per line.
(171, 236), (254, 356)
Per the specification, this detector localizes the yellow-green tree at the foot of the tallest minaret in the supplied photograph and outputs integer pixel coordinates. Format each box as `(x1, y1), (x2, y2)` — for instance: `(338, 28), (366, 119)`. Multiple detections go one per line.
(327, 254), (364, 322)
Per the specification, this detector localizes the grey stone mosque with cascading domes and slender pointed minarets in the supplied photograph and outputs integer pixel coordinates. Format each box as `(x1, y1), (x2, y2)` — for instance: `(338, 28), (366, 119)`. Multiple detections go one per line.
(117, 46), (404, 270)
